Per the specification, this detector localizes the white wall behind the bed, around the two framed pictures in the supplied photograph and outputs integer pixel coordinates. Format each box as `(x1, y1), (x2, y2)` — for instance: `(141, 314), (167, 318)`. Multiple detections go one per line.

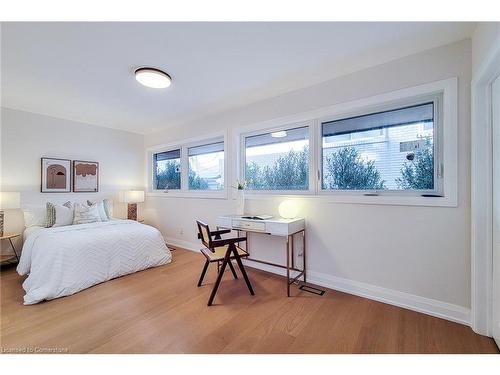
(0, 108), (144, 253)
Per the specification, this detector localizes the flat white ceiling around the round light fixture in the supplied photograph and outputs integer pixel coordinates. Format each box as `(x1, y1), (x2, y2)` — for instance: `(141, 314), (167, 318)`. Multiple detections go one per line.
(1, 22), (475, 133)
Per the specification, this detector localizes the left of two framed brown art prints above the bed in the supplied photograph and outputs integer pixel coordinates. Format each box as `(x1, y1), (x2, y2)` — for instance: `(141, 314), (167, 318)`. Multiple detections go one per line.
(40, 158), (71, 193)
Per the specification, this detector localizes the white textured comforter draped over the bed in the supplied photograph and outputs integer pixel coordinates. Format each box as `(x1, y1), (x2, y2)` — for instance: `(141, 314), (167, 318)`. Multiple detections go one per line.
(17, 220), (172, 305)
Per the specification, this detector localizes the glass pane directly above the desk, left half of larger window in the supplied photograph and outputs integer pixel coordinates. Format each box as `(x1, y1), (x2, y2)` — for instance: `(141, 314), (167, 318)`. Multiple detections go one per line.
(245, 127), (309, 190)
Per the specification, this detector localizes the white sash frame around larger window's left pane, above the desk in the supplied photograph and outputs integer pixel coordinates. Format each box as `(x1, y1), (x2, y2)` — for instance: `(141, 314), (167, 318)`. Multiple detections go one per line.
(237, 121), (316, 196)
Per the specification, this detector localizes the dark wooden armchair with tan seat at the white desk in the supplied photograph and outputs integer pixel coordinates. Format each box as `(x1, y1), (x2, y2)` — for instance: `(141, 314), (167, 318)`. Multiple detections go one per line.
(196, 220), (255, 306)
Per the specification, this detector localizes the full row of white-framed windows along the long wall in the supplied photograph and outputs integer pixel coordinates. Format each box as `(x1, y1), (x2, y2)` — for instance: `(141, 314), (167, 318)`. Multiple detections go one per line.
(150, 78), (461, 207)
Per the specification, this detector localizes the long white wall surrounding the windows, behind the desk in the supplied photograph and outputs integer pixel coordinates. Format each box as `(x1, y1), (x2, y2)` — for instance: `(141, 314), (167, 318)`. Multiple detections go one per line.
(145, 41), (471, 321)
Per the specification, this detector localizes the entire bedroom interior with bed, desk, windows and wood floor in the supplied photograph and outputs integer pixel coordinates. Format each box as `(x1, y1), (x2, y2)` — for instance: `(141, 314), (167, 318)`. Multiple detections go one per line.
(0, 0), (500, 374)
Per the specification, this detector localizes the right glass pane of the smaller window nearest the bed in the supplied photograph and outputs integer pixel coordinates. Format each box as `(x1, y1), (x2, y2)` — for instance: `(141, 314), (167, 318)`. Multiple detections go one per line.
(188, 142), (224, 190)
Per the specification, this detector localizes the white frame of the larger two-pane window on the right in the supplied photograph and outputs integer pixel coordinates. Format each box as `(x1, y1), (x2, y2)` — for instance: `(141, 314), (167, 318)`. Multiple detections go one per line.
(235, 77), (458, 207)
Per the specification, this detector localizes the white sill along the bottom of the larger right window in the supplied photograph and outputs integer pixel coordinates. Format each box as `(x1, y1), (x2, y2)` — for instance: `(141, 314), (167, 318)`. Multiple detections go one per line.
(245, 192), (458, 207)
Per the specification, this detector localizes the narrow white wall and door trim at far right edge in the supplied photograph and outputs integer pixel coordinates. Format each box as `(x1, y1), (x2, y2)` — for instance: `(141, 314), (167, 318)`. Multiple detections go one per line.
(471, 22), (500, 335)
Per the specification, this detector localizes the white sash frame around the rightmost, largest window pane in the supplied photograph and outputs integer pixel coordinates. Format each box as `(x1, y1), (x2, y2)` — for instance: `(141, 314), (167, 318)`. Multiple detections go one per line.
(316, 93), (444, 198)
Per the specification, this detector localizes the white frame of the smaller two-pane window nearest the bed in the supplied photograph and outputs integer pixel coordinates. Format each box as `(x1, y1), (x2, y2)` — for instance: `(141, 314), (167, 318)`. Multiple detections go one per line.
(146, 131), (229, 199)
